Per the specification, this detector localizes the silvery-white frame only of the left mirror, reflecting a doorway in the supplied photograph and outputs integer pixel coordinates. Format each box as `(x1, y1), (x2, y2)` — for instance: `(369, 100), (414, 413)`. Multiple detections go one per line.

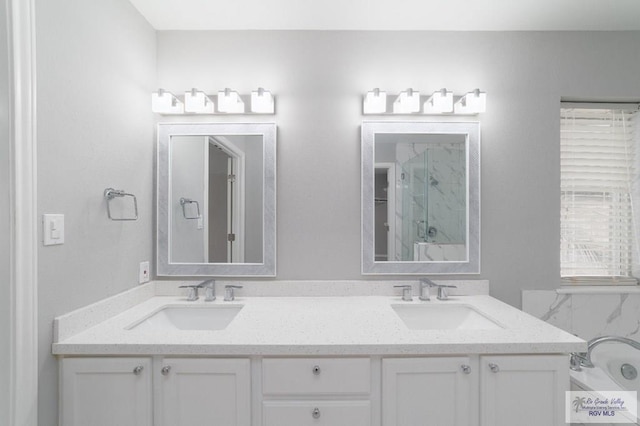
(156, 123), (276, 277)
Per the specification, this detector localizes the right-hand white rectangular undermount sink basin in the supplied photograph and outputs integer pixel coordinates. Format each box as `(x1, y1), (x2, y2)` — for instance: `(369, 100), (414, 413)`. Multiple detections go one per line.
(391, 303), (504, 330)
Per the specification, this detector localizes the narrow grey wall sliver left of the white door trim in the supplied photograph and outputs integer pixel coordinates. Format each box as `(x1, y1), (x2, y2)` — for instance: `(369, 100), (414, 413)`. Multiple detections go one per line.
(0, 0), (11, 426)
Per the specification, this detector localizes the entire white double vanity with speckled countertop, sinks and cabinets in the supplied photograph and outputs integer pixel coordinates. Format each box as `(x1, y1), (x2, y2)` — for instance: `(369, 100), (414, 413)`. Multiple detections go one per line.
(53, 281), (584, 426)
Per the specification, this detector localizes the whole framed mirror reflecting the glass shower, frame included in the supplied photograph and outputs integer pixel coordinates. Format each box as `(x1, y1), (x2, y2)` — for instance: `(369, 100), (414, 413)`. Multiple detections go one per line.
(362, 122), (480, 274)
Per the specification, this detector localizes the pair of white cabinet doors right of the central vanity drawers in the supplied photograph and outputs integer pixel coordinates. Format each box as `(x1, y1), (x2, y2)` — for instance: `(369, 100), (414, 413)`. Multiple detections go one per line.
(382, 355), (569, 426)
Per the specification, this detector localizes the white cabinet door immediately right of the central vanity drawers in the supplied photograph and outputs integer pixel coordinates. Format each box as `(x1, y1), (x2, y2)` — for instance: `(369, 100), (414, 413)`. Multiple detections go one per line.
(382, 357), (479, 426)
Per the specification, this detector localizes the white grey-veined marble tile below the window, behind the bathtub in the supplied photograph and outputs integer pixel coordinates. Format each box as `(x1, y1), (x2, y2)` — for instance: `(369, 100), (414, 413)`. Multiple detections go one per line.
(522, 287), (640, 340)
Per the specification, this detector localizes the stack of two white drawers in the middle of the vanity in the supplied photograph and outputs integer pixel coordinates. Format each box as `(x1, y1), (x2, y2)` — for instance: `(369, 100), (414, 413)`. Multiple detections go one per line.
(261, 358), (373, 426)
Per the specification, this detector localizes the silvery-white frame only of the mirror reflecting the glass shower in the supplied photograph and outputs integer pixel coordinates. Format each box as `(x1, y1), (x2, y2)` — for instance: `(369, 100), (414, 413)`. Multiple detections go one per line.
(361, 121), (480, 275)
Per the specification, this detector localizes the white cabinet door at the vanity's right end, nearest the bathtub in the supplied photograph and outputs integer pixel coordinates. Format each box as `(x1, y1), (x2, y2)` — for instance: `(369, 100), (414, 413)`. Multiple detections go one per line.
(480, 355), (569, 426)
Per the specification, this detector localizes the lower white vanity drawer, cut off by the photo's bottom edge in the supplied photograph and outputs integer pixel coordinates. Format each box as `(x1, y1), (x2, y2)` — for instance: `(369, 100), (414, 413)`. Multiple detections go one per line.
(262, 401), (371, 426)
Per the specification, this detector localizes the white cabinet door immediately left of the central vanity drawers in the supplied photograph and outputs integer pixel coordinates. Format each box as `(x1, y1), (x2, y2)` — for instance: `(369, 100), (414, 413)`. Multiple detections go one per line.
(158, 358), (251, 426)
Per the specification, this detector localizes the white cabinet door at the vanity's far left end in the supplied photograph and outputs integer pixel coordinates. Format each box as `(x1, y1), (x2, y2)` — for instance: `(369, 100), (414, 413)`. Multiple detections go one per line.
(60, 357), (153, 426)
